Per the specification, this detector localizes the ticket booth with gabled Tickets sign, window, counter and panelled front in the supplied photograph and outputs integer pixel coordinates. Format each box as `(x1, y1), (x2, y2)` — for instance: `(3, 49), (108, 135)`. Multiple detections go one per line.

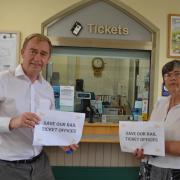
(42, 1), (155, 180)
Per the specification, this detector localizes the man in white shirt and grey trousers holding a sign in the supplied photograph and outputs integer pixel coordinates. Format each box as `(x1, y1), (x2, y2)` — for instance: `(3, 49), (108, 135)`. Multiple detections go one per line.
(0, 34), (77, 180)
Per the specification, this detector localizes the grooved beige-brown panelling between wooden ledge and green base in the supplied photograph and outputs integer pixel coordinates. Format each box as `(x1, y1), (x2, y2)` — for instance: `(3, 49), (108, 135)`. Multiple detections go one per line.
(45, 143), (139, 167)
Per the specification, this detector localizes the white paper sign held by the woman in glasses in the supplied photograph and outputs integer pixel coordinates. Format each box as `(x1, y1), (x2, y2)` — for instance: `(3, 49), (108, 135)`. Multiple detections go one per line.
(119, 121), (165, 156)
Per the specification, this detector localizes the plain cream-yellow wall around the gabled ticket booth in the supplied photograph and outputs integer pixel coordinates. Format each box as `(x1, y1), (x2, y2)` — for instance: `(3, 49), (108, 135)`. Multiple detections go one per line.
(0, 0), (180, 98)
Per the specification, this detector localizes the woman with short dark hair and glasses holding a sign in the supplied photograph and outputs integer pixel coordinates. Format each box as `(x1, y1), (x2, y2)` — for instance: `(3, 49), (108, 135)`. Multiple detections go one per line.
(134, 60), (180, 180)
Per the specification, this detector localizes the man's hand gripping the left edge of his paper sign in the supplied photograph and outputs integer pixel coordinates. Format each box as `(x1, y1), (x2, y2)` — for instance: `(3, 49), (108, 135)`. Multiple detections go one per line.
(9, 112), (40, 130)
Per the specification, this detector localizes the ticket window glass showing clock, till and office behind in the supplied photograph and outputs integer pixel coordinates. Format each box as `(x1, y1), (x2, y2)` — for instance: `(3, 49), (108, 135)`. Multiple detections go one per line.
(45, 47), (150, 122)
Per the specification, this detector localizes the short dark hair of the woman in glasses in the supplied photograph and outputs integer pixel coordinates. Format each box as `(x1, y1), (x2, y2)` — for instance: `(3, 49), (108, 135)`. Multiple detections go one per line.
(162, 59), (180, 77)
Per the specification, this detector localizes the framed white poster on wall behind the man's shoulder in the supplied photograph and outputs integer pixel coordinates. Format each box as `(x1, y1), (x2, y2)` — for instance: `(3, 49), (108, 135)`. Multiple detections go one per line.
(0, 31), (20, 71)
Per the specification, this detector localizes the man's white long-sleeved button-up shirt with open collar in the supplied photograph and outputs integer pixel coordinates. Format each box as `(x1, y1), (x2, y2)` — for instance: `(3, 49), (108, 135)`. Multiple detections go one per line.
(0, 65), (54, 161)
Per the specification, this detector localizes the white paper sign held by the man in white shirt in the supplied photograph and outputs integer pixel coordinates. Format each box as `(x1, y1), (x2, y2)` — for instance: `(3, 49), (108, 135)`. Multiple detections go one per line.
(33, 110), (85, 146)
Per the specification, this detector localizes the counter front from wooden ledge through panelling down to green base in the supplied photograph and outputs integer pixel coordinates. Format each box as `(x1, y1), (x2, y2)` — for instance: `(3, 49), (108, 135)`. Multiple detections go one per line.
(45, 122), (139, 180)
